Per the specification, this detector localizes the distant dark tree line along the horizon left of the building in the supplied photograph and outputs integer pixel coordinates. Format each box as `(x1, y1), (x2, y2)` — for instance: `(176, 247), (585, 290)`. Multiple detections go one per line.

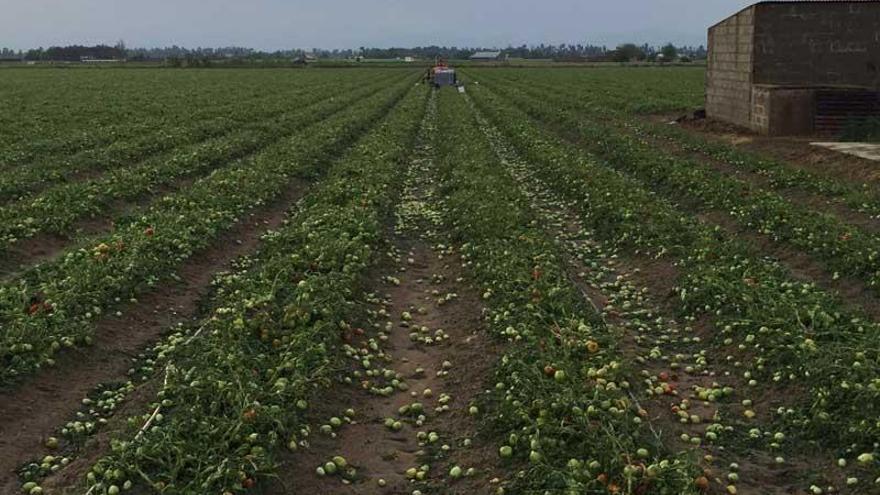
(0, 40), (706, 67)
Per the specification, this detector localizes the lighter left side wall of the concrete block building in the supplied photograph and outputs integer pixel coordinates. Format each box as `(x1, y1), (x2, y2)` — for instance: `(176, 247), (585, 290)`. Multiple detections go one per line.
(706, 6), (755, 127)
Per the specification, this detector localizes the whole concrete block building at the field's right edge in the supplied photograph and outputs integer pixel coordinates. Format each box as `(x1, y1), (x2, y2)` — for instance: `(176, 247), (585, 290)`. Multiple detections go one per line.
(706, 0), (880, 135)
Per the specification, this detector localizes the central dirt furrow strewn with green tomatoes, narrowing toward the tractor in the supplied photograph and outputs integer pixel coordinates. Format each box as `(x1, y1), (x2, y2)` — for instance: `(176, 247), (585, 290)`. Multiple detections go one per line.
(267, 97), (496, 495)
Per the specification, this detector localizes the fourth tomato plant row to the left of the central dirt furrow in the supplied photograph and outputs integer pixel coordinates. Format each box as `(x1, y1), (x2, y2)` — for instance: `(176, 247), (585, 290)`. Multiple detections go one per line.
(0, 70), (384, 204)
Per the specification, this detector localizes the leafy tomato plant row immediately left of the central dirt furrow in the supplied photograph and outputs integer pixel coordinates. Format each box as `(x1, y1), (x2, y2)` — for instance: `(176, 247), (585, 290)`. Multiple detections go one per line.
(75, 81), (425, 494)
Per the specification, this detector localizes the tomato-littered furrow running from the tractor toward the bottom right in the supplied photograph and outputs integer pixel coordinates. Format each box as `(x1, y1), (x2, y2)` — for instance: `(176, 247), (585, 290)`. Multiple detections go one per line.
(464, 90), (859, 493)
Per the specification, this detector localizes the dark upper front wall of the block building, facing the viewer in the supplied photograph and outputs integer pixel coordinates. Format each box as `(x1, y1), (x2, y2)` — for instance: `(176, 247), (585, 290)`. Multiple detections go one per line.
(752, 2), (880, 88)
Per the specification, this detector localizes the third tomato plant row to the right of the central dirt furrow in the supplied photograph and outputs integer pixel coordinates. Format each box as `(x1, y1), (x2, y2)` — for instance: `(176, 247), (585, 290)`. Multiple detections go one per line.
(470, 73), (880, 290)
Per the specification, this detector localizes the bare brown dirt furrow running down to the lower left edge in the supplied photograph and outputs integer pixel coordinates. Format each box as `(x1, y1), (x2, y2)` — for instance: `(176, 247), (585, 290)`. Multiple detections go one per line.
(0, 182), (306, 493)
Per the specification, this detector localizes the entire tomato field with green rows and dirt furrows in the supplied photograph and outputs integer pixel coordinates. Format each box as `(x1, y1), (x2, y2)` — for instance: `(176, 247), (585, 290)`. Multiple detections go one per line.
(0, 66), (880, 495)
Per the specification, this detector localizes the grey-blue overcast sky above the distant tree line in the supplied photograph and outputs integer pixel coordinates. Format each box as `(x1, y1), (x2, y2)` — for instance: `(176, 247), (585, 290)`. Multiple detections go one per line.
(0, 0), (752, 50)
